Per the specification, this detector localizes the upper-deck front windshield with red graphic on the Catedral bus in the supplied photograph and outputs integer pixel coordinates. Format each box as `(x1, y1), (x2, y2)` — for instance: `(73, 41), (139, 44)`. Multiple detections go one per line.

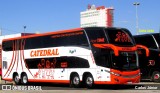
(105, 29), (134, 46)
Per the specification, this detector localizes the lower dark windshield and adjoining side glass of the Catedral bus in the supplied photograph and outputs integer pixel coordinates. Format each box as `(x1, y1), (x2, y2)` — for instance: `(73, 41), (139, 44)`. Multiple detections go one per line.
(95, 49), (138, 71)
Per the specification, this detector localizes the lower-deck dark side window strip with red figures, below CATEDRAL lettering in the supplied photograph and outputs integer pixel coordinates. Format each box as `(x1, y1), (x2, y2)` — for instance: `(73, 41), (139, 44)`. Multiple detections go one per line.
(26, 57), (89, 69)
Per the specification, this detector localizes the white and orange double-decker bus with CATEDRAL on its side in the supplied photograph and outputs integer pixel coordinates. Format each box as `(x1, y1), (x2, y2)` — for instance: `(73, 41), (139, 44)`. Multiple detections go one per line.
(2, 27), (149, 88)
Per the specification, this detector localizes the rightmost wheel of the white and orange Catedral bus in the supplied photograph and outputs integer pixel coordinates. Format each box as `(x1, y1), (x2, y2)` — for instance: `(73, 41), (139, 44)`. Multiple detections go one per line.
(84, 74), (94, 88)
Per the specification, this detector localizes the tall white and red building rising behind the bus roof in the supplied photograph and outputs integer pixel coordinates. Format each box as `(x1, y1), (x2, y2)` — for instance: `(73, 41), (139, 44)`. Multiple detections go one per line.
(80, 5), (114, 27)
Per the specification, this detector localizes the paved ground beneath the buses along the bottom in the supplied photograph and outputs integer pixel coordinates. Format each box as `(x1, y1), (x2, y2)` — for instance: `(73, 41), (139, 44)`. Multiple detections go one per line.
(0, 80), (160, 93)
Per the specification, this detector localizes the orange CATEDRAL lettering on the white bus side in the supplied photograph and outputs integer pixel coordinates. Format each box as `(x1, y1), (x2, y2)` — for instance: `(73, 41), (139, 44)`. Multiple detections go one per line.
(30, 49), (59, 57)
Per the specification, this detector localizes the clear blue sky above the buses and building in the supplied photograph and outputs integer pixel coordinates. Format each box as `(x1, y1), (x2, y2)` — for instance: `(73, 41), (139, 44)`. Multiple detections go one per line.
(0, 0), (160, 35)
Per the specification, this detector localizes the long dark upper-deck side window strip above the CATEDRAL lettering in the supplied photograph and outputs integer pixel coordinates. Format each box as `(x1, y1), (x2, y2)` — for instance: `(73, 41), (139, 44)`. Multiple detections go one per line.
(25, 31), (89, 49)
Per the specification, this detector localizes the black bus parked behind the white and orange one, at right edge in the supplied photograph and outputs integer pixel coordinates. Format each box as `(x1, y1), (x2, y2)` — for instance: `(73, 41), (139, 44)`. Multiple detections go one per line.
(134, 33), (160, 82)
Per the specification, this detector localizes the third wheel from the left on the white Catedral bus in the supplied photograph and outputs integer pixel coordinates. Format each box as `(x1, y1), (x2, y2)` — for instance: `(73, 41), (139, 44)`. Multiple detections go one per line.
(70, 74), (80, 88)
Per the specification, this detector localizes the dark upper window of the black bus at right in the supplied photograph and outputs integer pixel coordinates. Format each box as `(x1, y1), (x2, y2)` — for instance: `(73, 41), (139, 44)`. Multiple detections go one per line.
(135, 35), (157, 49)
